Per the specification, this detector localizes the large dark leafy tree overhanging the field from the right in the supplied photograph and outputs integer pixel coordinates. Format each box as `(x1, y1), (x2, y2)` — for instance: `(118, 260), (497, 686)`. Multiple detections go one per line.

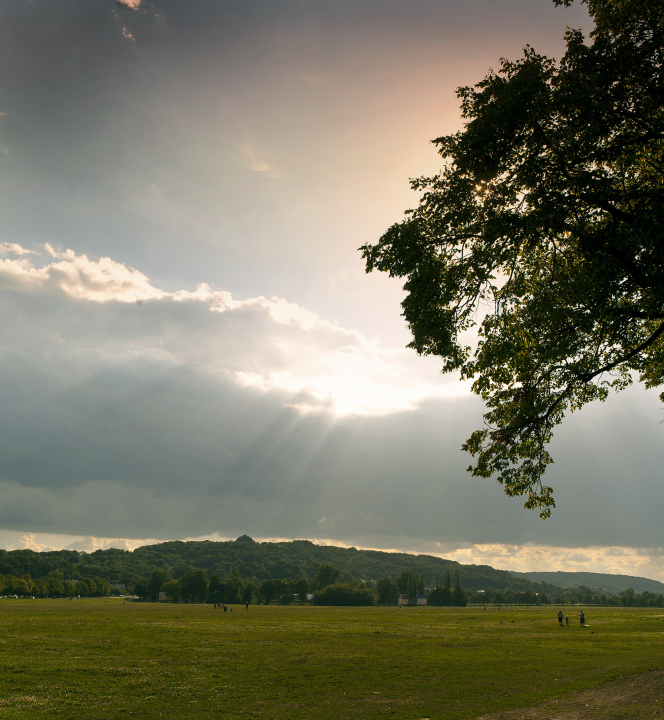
(361, 0), (664, 517)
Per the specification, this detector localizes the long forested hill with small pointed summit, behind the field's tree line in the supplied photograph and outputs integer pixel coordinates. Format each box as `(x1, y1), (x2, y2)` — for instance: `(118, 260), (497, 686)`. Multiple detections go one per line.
(0, 535), (551, 592)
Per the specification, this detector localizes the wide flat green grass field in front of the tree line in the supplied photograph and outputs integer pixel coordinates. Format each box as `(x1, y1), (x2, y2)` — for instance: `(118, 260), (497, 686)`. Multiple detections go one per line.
(0, 599), (664, 720)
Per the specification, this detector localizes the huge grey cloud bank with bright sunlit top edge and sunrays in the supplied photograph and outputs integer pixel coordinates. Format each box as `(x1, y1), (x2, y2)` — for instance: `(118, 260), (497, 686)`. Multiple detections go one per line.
(0, 245), (664, 548)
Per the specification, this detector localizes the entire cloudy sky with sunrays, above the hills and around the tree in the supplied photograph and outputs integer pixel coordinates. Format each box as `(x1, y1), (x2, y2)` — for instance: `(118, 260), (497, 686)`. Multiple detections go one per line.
(0, 0), (664, 580)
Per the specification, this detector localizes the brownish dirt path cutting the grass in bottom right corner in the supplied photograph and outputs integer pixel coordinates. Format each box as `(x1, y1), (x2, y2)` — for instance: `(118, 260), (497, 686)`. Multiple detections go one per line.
(476, 670), (664, 720)
